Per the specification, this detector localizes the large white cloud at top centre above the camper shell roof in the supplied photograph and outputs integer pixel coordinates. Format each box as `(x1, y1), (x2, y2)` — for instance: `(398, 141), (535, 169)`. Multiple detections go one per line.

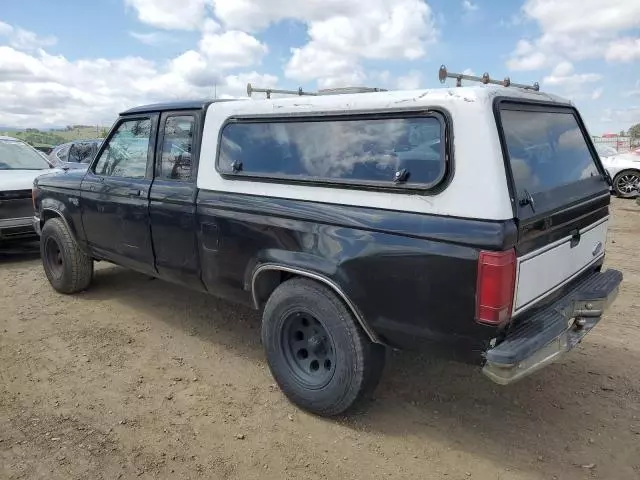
(210, 0), (438, 86)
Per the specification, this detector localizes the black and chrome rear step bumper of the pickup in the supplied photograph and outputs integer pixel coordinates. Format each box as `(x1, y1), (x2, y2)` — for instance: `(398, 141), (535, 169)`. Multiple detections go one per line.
(482, 270), (622, 385)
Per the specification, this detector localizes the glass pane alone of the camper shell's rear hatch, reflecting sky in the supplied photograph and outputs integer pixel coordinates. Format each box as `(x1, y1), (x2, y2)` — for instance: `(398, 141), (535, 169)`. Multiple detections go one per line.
(501, 107), (599, 198)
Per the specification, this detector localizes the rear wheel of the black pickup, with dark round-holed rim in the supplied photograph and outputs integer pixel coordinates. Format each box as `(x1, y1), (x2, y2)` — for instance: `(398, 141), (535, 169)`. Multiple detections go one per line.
(262, 278), (386, 416)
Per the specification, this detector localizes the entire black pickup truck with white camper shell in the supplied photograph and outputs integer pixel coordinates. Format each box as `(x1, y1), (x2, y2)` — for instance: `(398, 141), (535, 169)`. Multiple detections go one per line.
(34, 77), (622, 415)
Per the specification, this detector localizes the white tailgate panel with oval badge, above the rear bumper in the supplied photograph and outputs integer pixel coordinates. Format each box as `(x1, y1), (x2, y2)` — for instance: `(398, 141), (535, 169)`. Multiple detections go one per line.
(513, 217), (609, 315)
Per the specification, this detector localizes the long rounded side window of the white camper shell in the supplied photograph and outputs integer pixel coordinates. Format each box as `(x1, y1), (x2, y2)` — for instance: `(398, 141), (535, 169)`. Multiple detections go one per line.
(217, 115), (447, 189)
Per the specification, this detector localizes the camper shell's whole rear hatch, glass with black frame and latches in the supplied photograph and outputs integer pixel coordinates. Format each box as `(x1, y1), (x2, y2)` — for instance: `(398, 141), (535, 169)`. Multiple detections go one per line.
(498, 102), (608, 216)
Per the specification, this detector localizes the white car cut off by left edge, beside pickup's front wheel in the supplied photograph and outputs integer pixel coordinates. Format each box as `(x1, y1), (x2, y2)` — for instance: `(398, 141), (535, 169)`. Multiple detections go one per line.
(0, 136), (51, 244)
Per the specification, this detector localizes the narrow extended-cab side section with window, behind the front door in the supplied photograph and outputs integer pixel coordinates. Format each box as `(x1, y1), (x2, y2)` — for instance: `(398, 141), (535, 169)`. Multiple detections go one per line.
(149, 110), (204, 290)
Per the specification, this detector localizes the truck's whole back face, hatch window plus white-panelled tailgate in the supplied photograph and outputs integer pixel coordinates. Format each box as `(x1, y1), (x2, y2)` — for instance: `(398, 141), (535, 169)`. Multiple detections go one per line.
(499, 101), (610, 316)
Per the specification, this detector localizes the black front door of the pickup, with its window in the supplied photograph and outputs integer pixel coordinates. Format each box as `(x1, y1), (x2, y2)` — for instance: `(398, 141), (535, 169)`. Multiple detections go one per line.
(81, 114), (158, 273)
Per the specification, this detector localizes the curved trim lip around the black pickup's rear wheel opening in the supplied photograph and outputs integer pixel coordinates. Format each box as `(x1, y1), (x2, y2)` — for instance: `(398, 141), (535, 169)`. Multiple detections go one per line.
(250, 263), (384, 344)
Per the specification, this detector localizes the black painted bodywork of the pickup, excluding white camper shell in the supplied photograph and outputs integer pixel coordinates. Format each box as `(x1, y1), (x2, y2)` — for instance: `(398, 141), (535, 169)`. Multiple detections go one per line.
(36, 100), (609, 361)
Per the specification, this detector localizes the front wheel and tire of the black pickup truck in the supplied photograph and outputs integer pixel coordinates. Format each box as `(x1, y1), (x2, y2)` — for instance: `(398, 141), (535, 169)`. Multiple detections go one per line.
(40, 218), (93, 294)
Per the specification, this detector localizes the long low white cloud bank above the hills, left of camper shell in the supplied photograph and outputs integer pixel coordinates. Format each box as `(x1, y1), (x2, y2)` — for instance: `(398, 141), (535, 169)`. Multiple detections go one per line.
(0, 42), (278, 126)
